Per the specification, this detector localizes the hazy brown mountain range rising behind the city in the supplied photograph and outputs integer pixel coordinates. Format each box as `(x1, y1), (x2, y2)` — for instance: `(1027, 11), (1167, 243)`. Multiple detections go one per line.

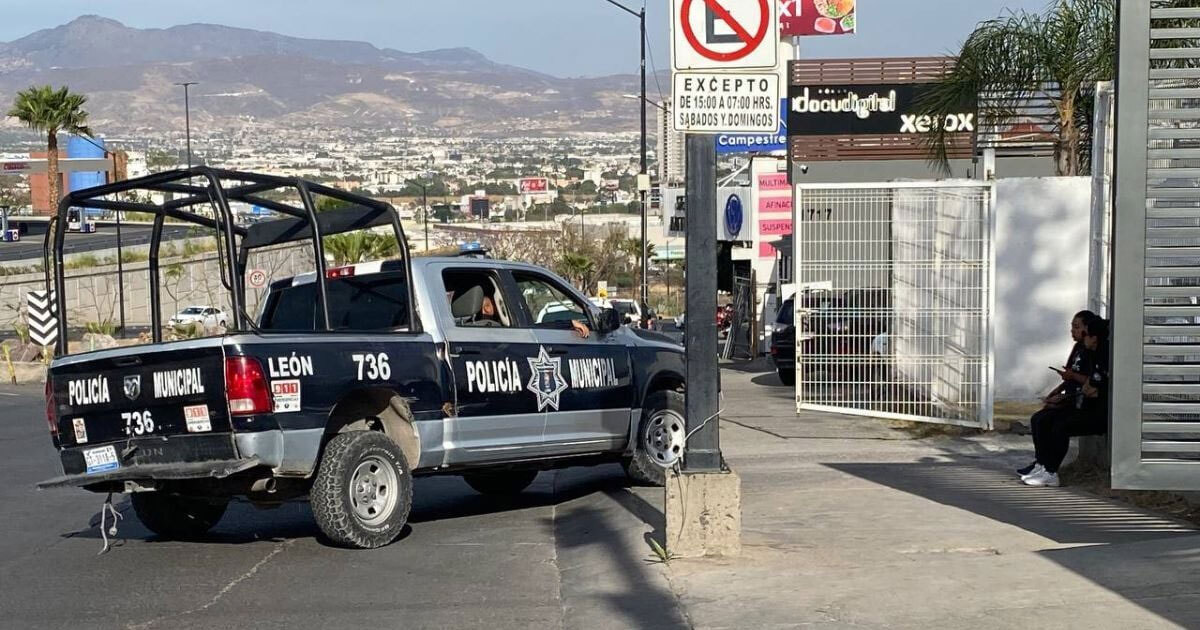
(0, 16), (657, 136)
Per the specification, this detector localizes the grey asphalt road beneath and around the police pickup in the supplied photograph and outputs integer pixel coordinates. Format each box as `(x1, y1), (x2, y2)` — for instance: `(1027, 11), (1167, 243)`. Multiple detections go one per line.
(0, 386), (685, 630)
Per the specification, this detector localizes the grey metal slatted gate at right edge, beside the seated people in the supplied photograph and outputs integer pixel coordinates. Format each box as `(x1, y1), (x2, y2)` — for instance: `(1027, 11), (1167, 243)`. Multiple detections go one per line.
(1111, 0), (1200, 490)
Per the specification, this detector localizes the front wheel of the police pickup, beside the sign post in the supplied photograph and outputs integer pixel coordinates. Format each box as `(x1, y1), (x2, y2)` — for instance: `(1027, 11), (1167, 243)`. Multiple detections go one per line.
(624, 391), (688, 486)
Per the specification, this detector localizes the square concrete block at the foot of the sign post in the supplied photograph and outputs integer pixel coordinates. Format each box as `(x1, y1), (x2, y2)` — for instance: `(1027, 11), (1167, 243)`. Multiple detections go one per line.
(666, 469), (742, 558)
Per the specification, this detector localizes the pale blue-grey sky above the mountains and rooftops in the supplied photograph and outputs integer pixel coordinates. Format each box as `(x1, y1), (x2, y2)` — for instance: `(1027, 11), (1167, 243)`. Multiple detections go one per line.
(0, 0), (1049, 77)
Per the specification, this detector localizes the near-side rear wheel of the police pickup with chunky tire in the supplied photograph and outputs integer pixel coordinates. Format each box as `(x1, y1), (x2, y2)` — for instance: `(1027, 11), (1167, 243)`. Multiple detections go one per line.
(310, 431), (413, 548)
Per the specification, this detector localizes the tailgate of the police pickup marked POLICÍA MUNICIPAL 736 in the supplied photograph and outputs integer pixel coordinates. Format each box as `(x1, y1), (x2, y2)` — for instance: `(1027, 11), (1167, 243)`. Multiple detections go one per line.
(49, 337), (236, 478)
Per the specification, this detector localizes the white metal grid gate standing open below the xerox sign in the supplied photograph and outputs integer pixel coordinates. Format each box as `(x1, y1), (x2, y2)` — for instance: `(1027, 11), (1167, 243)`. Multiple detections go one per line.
(794, 180), (995, 428)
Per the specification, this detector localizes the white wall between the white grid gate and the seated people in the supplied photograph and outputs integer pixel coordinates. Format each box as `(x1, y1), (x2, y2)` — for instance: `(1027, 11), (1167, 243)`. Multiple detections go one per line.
(995, 178), (1091, 401)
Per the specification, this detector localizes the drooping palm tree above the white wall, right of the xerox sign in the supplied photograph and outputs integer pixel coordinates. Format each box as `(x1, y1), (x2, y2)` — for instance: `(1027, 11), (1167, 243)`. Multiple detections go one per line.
(918, 0), (1116, 175)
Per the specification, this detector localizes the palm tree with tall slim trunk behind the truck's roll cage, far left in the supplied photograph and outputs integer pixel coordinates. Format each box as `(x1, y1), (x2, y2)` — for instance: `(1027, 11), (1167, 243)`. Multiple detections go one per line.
(8, 85), (92, 211)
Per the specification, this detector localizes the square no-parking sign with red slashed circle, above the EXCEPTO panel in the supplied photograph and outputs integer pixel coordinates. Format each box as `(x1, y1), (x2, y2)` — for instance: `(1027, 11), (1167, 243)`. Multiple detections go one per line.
(671, 0), (779, 71)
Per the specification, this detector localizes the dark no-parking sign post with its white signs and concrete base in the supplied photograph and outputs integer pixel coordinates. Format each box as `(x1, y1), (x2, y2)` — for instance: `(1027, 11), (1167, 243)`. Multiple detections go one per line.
(665, 0), (748, 558)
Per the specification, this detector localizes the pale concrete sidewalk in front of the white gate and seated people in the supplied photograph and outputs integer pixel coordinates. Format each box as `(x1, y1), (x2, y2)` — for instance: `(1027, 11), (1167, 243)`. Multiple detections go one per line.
(667, 370), (1200, 629)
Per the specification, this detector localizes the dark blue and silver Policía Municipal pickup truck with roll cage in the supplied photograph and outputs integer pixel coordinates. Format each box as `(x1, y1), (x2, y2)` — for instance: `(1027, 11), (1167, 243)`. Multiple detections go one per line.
(42, 167), (685, 547)
